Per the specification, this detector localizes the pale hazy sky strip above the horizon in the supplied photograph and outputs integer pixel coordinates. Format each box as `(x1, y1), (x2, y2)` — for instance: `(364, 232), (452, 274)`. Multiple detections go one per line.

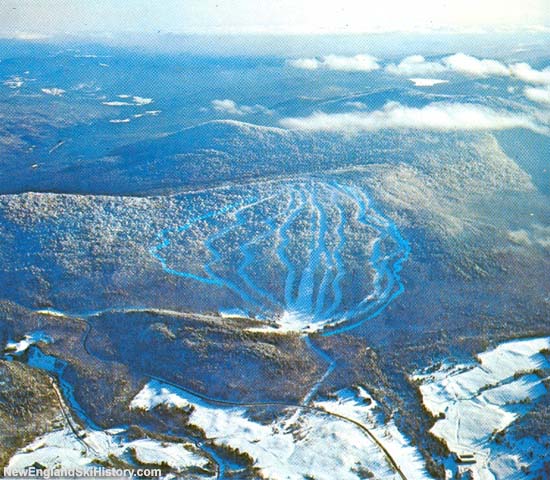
(0, 0), (550, 39)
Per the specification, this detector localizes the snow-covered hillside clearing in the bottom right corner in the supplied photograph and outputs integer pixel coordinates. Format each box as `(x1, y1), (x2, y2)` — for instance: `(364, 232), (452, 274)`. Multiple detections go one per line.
(413, 337), (550, 480)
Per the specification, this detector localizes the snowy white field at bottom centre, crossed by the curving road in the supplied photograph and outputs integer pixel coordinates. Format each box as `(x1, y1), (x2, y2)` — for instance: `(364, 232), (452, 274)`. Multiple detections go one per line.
(131, 380), (429, 480)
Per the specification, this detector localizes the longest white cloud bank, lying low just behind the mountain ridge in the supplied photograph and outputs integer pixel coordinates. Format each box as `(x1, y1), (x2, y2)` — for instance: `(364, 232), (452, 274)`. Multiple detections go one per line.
(280, 102), (548, 134)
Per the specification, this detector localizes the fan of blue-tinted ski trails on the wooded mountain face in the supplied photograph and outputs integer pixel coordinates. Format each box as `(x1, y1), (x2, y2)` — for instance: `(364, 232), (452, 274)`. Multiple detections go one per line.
(150, 180), (410, 333)
